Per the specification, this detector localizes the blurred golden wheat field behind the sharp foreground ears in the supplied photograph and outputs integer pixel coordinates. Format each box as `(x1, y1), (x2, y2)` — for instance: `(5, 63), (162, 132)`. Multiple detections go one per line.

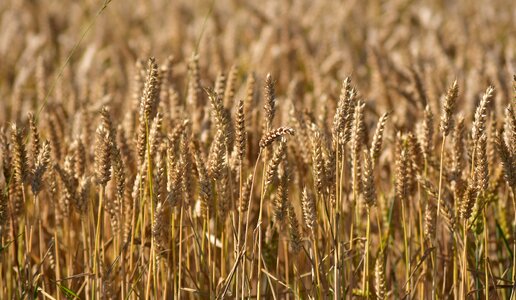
(0, 0), (516, 121)
